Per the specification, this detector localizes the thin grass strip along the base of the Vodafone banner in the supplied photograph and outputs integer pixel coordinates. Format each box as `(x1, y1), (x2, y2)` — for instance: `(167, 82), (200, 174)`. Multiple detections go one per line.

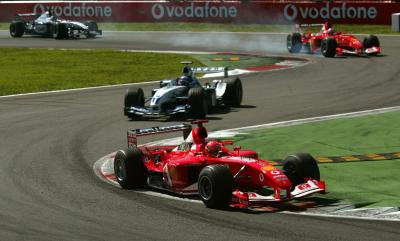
(0, 22), (399, 34)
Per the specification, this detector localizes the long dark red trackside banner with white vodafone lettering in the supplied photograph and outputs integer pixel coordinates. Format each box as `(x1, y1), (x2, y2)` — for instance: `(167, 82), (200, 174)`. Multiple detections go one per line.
(0, 1), (400, 25)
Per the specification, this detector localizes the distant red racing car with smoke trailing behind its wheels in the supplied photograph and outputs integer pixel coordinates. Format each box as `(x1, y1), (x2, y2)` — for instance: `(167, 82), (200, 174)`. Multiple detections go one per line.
(286, 23), (381, 57)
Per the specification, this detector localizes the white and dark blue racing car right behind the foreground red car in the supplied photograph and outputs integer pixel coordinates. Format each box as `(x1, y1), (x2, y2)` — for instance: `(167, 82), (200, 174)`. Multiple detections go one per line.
(124, 61), (243, 120)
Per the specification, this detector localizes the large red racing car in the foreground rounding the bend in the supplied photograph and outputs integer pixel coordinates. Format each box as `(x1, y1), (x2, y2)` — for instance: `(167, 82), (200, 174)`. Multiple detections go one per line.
(114, 120), (325, 208)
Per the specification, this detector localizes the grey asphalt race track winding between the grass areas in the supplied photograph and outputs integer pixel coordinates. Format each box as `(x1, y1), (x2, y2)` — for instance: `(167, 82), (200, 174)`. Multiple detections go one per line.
(0, 31), (400, 241)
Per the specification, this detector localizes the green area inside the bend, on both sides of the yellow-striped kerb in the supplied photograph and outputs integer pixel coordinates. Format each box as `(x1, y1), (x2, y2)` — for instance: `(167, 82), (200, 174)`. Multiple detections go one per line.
(233, 112), (400, 206)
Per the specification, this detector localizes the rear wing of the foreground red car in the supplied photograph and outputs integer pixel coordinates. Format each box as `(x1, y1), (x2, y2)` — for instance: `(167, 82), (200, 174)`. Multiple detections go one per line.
(127, 123), (192, 147)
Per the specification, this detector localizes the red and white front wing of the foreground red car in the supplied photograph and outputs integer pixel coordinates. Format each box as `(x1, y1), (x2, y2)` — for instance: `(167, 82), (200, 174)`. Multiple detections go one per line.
(231, 180), (325, 208)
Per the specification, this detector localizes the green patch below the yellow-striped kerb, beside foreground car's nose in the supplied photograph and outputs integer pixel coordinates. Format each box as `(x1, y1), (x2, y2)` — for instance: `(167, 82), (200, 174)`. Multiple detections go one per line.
(319, 160), (400, 207)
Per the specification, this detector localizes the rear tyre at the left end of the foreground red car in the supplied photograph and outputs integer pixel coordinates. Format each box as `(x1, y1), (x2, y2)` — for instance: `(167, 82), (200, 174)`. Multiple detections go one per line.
(114, 147), (147, 189)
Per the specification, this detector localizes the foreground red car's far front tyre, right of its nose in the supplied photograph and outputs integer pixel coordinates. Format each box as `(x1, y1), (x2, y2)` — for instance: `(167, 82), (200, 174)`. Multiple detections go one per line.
(283, 153), (320, 188)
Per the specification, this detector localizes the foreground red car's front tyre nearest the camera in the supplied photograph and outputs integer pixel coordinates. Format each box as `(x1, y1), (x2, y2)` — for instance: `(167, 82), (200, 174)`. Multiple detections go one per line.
(198, 165), (234, 209)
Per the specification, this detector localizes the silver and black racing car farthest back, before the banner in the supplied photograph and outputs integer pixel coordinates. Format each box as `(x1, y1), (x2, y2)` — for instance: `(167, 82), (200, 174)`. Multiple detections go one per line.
(10, 11), (102, 39)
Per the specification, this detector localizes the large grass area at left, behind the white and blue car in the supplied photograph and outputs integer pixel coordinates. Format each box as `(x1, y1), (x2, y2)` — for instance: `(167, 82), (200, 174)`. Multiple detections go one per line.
(0, 48), (203, 95)
